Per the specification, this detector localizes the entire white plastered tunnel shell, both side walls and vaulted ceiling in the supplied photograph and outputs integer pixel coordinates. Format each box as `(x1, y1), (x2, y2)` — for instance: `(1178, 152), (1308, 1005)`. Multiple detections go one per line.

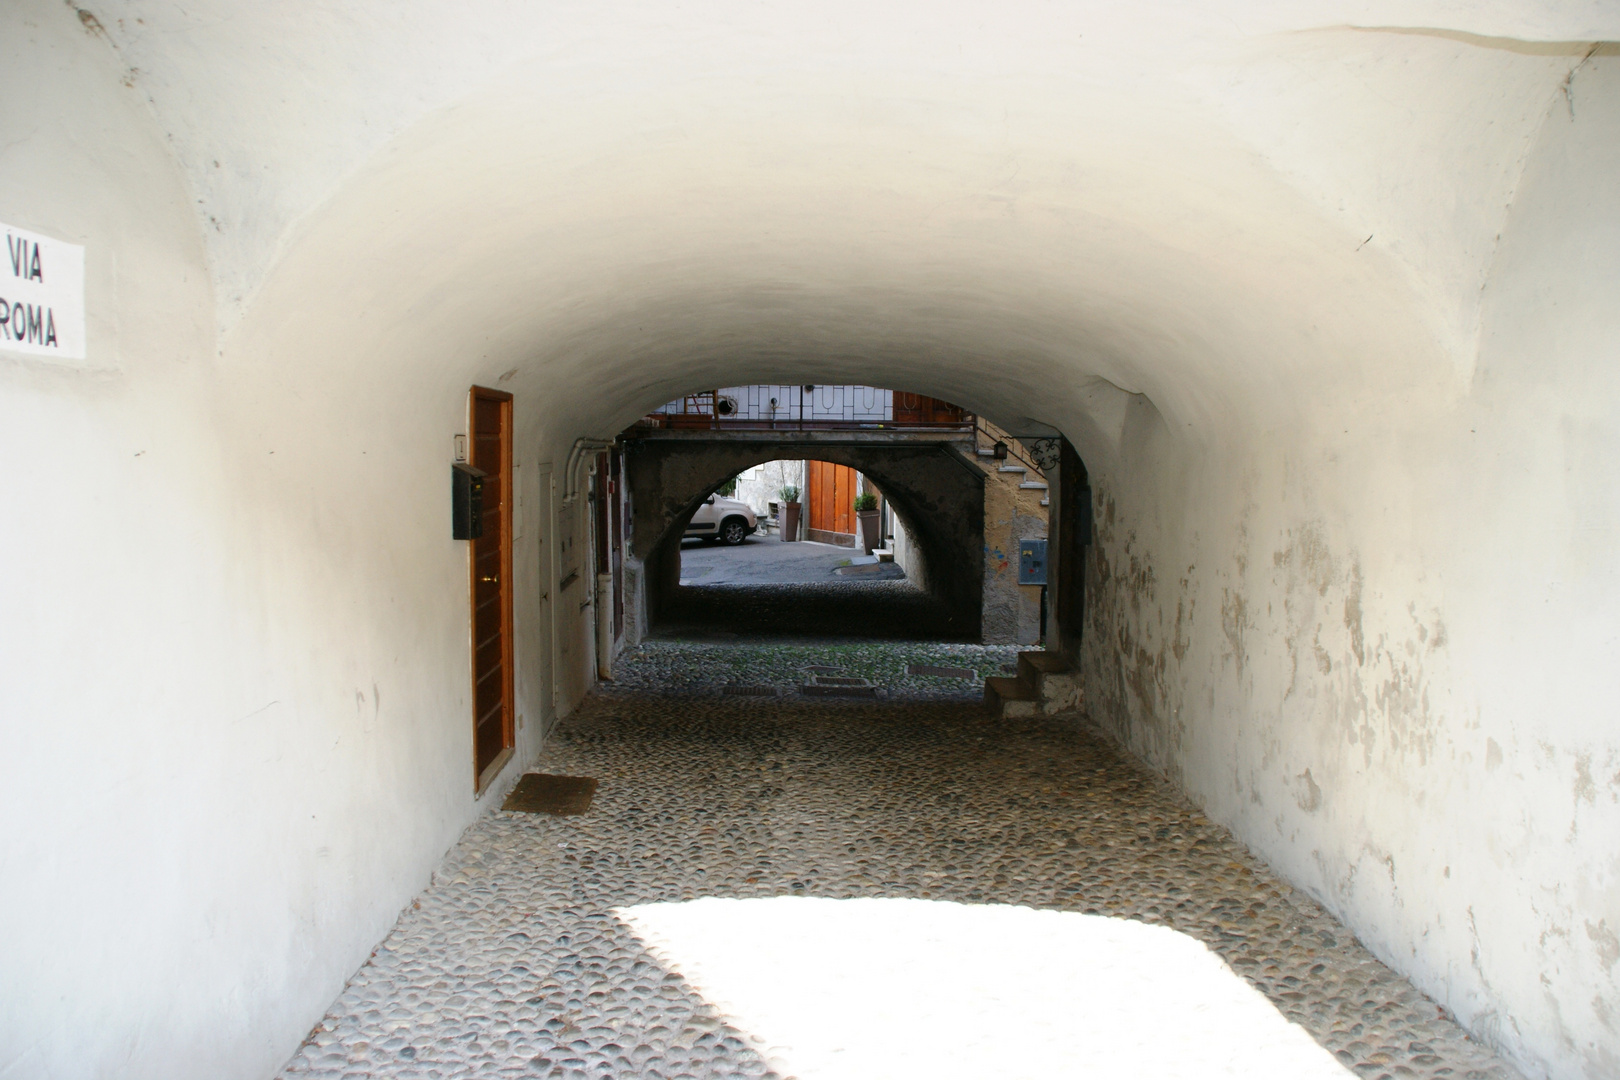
(0, 0), (1620, 1077)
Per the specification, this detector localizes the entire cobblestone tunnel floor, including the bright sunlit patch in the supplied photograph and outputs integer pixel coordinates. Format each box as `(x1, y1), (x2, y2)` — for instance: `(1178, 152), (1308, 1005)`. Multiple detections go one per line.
(282, 643), (1518, 1080)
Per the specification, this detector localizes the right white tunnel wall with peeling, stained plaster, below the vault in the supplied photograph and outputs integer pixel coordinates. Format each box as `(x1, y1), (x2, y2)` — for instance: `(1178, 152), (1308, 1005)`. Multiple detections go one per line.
(1084, 49), (1620, 1077)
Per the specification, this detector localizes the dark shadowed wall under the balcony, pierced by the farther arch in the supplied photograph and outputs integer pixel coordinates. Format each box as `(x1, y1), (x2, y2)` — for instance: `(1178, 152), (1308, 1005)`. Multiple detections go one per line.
(625, 431), (985, 641)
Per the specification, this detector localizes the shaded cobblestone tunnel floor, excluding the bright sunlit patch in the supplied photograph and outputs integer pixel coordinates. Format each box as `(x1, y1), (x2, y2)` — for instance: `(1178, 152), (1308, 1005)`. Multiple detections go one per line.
(282, 644), (1518, 1080)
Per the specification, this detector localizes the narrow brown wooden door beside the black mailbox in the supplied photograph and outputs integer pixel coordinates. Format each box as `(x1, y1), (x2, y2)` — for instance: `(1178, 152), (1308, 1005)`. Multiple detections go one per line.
(468, 387), (514, 792)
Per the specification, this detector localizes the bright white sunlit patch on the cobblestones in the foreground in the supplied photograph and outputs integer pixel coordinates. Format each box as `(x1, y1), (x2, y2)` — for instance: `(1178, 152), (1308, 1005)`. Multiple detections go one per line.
(617, 897), (1354, 1080)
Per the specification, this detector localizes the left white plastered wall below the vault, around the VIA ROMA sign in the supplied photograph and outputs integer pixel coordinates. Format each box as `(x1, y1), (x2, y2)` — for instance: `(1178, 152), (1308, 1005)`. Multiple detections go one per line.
(0, 3), (557, 1080)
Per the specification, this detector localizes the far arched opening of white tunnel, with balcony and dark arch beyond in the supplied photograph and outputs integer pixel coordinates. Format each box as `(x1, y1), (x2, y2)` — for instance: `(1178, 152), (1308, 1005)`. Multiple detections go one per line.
(616, 384), (1079, 644)
